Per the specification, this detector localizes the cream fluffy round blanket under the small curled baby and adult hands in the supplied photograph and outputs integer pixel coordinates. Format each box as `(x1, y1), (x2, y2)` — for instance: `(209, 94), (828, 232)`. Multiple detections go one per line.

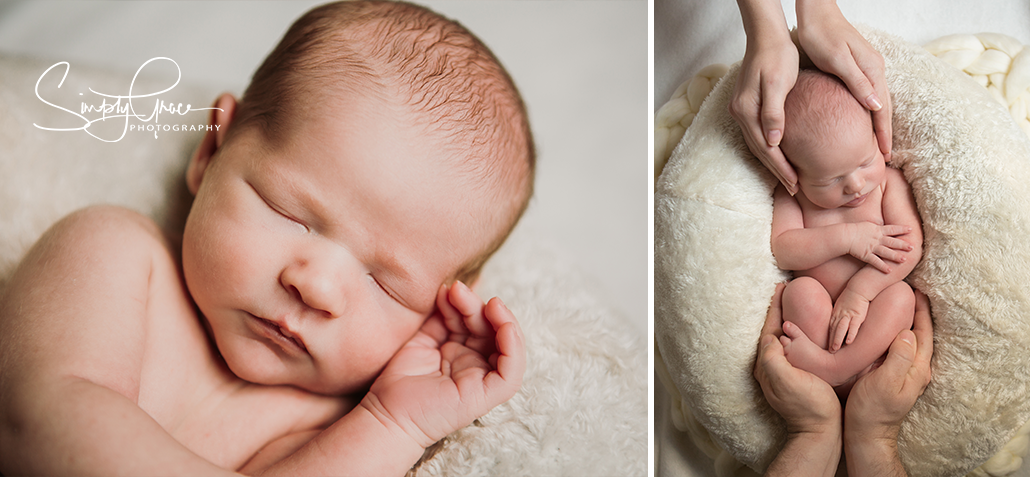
(655, 30), (1030, 475)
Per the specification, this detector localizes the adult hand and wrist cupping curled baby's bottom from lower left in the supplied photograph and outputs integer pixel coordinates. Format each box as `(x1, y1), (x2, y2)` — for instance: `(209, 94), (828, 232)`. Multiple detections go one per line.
(755, 284), (842, 476)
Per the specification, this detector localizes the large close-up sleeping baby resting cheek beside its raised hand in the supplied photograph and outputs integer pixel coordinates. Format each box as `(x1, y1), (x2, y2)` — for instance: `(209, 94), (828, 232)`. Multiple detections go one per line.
(0, 2), (535, 475)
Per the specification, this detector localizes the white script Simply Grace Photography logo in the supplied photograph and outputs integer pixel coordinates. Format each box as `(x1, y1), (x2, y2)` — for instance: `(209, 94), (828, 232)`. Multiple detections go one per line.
(32, 57), (220, 142)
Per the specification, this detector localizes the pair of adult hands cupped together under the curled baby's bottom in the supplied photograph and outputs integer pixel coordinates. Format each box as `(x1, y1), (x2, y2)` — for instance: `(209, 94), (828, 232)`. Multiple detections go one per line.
(754, 285), (933, 476)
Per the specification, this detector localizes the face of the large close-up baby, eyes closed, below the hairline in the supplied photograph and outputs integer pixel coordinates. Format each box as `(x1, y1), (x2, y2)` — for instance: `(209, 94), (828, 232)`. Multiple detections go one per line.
(182, 95), (499, 395)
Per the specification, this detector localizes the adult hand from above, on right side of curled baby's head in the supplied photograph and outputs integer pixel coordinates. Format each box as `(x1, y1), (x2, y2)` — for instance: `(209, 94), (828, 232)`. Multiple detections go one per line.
(797, 0), (892, 161)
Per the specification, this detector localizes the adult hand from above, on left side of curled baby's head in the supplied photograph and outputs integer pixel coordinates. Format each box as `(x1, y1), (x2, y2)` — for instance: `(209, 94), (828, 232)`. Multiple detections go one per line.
(729, 0), (799, 196)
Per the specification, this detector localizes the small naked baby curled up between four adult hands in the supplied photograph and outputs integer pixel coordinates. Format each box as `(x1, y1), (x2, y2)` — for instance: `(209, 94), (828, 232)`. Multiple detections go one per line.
(773, 66), (923, 396)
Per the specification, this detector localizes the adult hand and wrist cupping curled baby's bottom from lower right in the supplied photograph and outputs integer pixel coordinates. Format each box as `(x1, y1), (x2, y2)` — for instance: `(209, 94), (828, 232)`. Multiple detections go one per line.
(844, 291), (933, 476)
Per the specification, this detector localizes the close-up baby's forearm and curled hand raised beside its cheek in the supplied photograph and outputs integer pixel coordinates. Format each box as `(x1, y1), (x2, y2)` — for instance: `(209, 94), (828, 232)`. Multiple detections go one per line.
(250, 282), (525, 475)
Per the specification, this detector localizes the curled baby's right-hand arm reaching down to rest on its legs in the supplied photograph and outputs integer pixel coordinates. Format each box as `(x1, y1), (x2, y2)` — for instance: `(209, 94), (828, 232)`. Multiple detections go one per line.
(829, 168), (923, 351)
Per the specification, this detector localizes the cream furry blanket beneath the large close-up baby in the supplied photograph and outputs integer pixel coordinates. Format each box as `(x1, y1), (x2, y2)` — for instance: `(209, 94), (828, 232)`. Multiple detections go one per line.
(0, 56), (647, 476)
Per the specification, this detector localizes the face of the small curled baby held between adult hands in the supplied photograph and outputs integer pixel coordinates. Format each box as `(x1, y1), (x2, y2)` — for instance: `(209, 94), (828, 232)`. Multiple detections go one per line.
(790, 119), (886, 209)
